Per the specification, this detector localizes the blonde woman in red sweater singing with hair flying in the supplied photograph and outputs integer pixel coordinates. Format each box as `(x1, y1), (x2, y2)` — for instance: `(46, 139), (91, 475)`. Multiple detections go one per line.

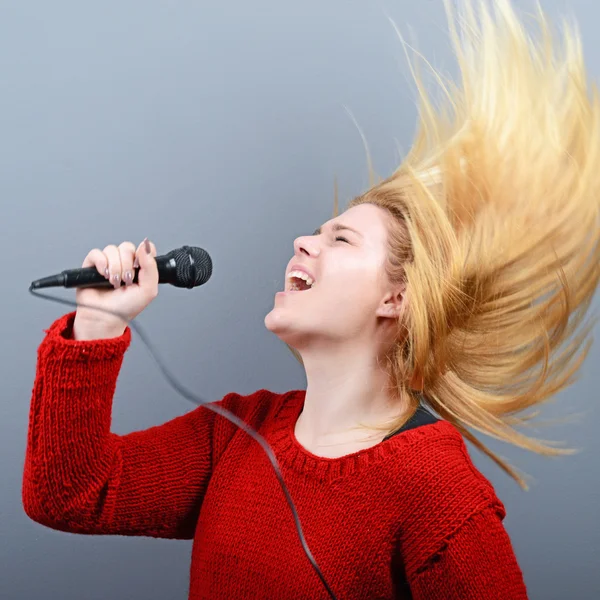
(23, 0), (600, 600)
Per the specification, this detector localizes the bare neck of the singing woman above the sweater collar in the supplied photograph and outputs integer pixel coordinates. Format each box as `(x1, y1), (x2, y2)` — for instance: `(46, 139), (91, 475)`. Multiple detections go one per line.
(296, 341), (407, 444)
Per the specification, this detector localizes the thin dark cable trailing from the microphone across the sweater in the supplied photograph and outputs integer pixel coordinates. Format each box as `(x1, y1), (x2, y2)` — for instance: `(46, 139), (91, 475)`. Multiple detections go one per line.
(29, 286), (337, 600)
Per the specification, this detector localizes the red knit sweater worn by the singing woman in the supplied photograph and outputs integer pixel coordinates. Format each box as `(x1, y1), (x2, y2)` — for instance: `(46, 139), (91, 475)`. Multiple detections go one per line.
(23, 313), (526, 600)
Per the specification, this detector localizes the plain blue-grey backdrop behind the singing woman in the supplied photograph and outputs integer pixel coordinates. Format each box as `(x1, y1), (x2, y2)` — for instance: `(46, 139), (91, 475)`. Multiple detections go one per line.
(0, 0), (600, 600)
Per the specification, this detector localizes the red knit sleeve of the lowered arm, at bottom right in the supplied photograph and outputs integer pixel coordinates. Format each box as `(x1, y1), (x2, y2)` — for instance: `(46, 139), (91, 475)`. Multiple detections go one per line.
(409, 507), (527, 600)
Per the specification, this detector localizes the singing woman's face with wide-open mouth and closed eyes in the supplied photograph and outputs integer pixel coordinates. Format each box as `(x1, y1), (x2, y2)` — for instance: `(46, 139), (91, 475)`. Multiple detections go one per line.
(265, 204), (399, 350)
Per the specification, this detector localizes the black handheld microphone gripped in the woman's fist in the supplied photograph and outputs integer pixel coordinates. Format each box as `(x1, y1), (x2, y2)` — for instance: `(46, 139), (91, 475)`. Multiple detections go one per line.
(30, 246), (212, 289)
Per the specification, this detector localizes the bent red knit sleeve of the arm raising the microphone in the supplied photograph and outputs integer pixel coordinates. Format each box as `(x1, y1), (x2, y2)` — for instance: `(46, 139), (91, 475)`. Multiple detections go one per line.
(22, 313), (260, 539)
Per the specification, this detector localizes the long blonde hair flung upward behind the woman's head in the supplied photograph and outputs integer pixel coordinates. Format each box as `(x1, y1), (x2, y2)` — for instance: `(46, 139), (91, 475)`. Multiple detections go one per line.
(292, 0), (600, 489)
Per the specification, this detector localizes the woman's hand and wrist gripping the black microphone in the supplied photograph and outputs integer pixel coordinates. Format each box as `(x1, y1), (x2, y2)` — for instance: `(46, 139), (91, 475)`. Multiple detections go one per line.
(73, 238), (158, 340)
